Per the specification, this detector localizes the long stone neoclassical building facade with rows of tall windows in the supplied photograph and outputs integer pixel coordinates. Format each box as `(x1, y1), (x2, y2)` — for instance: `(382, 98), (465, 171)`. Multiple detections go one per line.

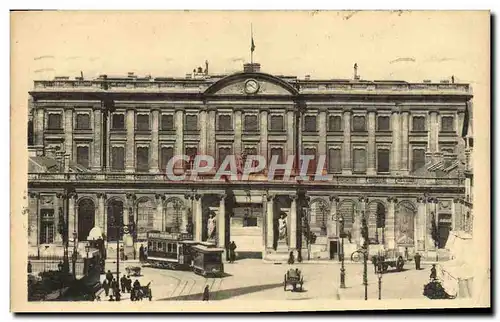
(28, 64), (472, 259)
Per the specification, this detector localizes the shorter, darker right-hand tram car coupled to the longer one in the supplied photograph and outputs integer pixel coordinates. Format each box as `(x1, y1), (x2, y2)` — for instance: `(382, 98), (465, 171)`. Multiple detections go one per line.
(192, 242), (224, 277)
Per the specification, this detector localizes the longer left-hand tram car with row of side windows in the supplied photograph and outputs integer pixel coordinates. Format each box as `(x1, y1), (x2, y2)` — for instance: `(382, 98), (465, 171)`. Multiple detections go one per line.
(145, 231), (197, 270)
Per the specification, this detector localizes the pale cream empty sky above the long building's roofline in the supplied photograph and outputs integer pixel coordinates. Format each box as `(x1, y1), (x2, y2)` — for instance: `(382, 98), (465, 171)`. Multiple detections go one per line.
(11, 11), (489, 109)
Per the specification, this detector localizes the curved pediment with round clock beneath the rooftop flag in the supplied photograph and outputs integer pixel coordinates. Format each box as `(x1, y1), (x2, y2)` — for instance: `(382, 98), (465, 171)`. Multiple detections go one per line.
(206, 73), (297, 96)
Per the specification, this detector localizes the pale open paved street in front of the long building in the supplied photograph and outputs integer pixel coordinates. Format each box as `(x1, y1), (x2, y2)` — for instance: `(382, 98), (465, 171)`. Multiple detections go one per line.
(102, 259), (429, 301)
